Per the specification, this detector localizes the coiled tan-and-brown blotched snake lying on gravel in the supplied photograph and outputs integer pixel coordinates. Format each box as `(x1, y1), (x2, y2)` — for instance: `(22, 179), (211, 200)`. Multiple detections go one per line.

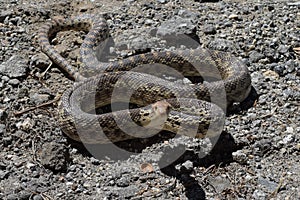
(38, 15), (251, 143)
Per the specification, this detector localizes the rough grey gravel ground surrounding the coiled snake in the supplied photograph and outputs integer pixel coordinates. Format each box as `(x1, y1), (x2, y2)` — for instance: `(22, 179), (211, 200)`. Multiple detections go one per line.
(0, 0), (300, 200)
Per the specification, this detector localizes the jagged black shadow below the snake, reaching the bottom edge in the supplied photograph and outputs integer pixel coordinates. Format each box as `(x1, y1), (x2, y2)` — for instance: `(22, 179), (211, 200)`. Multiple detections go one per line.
(160, 132), (242, 199)
